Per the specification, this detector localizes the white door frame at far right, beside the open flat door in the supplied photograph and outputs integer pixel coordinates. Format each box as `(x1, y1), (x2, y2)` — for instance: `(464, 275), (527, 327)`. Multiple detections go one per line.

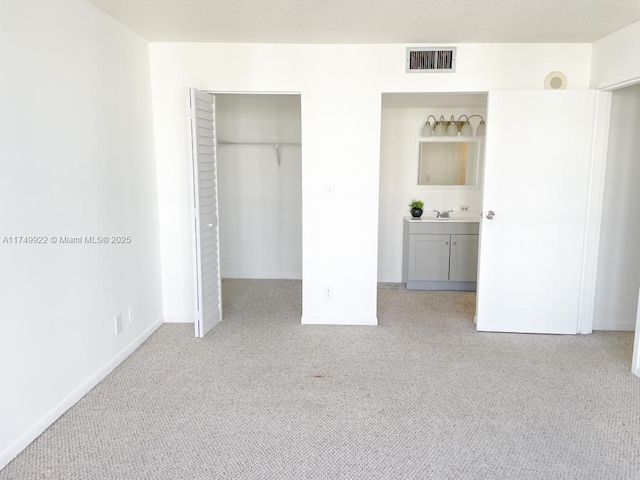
(577, 75), (640, 334)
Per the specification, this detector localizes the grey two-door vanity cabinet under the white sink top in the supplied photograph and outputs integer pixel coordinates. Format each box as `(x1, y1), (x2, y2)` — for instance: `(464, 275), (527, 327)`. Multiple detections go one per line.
(402, 218), (479, 291)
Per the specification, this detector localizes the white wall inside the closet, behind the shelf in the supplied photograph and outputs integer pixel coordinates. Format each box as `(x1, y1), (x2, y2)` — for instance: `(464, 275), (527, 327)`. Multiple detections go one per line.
(216, 95), (302, 279)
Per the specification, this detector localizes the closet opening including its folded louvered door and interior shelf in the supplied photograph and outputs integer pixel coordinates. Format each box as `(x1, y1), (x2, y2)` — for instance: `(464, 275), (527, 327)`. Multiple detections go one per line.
(189, 88), (302, 337)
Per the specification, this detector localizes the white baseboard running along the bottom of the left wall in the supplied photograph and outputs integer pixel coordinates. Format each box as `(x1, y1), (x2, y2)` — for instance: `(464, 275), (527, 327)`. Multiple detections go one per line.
(0, 317), (164, 470)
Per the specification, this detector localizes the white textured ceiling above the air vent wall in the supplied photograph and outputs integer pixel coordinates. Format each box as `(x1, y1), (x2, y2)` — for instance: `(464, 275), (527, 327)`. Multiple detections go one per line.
(89, 0), (640, 44)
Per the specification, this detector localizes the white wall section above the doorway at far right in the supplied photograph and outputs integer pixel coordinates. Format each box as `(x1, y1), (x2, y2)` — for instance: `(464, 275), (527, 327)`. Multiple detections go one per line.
(591, 22), (640, 88)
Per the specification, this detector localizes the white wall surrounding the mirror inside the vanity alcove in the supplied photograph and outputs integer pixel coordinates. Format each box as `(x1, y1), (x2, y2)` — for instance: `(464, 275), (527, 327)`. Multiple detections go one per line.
(378, 107), (486, 282)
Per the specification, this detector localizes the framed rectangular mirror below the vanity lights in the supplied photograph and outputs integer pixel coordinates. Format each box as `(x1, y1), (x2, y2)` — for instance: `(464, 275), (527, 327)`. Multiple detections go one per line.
(414, 137), (481, 188)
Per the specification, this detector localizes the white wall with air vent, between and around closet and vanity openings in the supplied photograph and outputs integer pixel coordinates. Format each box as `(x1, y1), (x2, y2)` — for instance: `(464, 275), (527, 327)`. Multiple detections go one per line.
(150, 43), (591, 324)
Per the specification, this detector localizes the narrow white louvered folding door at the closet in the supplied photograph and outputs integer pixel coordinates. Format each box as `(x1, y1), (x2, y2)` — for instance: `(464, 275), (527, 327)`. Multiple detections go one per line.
(189, 88), (222, 337)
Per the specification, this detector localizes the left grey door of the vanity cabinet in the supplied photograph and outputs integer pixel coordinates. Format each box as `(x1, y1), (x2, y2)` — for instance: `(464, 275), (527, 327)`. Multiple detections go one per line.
(409, 235), (451, 280)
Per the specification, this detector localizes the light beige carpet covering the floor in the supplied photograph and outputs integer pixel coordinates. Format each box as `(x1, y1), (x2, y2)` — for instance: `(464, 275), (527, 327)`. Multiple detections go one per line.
(0, 280), (640, 480)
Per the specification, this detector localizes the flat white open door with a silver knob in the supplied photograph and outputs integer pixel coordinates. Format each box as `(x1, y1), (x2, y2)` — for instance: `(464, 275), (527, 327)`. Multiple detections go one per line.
(477, 90), (596, 334)
